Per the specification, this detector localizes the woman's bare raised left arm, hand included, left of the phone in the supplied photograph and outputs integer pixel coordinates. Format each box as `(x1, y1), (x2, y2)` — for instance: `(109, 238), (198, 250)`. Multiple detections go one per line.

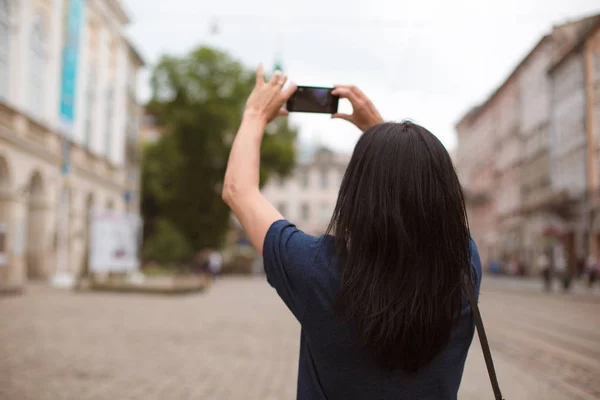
(222, 65), (296, 254)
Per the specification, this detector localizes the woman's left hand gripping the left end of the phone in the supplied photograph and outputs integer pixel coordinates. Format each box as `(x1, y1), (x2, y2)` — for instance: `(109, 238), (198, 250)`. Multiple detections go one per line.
(244, 64), (297, 124)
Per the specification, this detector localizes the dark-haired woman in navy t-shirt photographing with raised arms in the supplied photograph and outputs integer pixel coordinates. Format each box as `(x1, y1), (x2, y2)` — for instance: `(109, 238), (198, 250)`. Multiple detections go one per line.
(223, 67), (502, 400)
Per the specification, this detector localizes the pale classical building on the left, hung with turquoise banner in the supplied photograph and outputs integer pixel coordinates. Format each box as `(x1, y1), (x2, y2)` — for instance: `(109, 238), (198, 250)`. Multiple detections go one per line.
(0, 0), (143, 286)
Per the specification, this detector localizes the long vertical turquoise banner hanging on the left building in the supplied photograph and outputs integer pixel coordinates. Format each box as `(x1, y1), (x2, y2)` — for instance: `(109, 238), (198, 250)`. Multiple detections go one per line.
(60, 0), (85, 136)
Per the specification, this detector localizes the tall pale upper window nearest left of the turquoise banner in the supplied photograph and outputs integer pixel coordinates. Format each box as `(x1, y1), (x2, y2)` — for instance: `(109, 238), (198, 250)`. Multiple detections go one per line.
(28, 15), (46, 118)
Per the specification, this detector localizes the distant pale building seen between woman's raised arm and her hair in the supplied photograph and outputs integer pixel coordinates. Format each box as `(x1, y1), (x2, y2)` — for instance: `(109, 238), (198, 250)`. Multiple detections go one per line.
(262, 149), (350, 236)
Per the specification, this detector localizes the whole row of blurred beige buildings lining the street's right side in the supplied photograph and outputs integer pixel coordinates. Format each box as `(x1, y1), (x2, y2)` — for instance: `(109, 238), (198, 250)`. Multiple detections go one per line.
(456, 16), (600, 273)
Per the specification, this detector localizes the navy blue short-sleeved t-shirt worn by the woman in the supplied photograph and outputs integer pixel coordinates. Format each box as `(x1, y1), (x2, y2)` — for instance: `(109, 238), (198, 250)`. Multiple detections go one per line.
(263, 220), (481, 400)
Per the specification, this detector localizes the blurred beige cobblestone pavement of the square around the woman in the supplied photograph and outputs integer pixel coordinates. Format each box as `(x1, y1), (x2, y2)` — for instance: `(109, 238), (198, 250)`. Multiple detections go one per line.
(0, 278), (600, 400)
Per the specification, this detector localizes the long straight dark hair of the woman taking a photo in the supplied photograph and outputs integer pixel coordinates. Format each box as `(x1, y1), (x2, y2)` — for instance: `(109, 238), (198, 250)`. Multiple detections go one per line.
(328, 121), (471, 372)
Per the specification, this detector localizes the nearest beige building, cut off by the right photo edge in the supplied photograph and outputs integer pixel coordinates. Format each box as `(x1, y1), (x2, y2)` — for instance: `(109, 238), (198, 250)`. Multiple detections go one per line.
(549, 15), (600, 272)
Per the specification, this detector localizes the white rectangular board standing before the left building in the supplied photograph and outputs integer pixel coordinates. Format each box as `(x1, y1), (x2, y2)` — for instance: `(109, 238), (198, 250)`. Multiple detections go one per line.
(90, 211), (142, 272)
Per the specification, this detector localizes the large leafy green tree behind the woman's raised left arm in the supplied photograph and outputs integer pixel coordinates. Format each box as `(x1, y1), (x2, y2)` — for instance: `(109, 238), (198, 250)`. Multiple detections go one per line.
(142, 47), (297, 250)
